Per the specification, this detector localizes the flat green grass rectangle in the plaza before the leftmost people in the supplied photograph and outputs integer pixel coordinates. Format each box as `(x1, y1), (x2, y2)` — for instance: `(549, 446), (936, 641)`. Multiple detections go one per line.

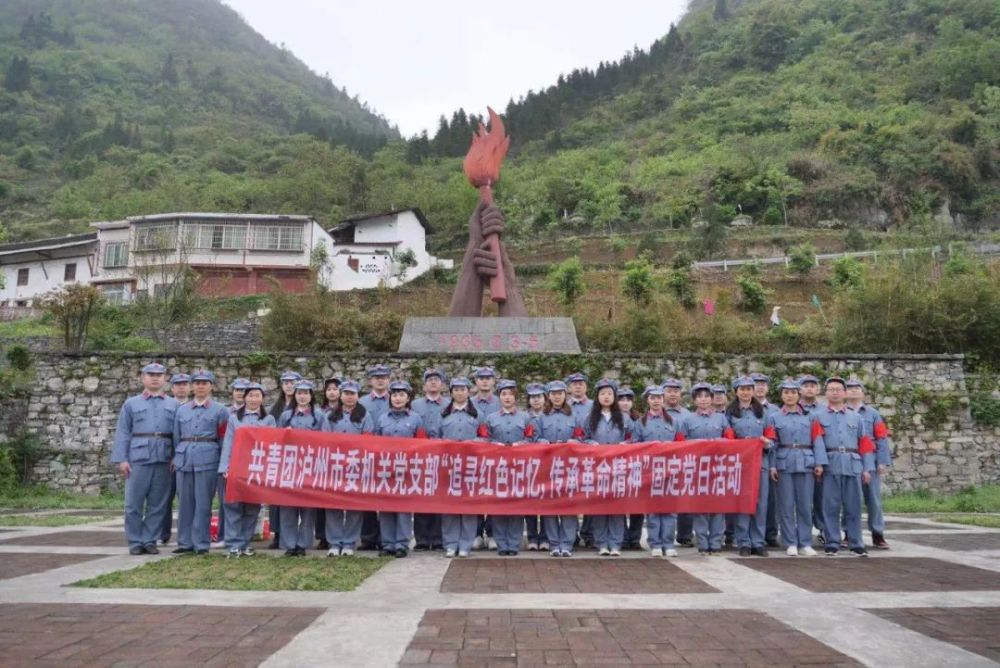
(73, 554), (391, 591)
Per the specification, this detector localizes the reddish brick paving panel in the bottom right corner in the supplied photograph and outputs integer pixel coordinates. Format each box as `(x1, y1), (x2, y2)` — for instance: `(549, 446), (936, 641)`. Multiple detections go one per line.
(866, 608), (1000, 662)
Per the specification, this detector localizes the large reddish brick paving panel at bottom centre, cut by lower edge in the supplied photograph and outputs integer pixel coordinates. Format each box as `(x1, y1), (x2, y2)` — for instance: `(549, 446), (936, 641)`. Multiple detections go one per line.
(400, 609), (859, 666)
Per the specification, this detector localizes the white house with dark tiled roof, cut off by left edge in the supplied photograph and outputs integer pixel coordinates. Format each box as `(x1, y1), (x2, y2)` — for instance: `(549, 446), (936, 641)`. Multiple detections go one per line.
(0, 232), (97, 307)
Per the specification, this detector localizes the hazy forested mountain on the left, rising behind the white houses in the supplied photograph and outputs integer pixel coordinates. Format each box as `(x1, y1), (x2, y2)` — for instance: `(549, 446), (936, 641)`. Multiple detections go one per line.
(0, 0), (398, 240)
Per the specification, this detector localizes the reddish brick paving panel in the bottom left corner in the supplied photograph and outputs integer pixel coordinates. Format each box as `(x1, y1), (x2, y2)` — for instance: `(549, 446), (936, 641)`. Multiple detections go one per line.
(0, 603), (323, 668)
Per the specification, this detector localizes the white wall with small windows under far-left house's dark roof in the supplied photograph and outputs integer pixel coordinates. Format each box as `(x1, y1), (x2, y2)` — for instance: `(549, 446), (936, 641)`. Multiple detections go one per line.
(0, 242), (95, 306)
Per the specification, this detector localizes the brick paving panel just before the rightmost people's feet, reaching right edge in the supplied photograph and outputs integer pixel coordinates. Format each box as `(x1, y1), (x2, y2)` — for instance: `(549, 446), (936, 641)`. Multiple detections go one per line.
(733, 555), (1000, 593)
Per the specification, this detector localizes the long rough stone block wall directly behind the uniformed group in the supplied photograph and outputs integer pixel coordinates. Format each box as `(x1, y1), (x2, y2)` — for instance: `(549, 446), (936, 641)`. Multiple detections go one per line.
(0, 352), (1000, 492)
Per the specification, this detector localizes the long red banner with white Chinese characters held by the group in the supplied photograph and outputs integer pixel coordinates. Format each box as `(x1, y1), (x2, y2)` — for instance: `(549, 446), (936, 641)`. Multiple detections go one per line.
(226, 426), (761, 515)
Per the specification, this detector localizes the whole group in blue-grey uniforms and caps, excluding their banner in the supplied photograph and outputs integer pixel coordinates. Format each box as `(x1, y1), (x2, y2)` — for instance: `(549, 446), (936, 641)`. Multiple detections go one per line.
(111, 363), (891, 558)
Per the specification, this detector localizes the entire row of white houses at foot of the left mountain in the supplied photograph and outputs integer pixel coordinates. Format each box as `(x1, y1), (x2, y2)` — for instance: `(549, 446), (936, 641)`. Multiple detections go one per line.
(0, 209), (453, 307)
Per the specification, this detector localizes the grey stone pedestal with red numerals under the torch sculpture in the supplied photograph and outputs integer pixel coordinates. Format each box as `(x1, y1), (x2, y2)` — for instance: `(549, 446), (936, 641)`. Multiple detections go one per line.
(399, 317), (580, 353)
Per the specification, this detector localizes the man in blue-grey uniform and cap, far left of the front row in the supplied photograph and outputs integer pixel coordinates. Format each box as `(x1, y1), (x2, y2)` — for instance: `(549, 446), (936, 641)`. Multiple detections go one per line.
(111, 363), (177, 555)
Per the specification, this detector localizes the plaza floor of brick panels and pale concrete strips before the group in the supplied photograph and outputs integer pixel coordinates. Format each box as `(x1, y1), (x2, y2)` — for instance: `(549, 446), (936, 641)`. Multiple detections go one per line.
(0, 511), (1000, 668)
